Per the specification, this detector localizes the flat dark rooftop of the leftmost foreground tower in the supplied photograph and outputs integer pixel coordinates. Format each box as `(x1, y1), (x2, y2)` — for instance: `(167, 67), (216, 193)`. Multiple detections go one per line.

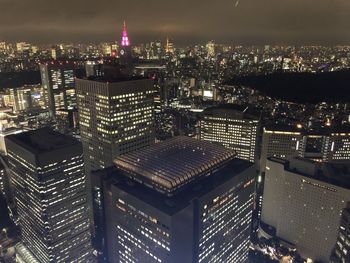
(6, 128), (79, 154)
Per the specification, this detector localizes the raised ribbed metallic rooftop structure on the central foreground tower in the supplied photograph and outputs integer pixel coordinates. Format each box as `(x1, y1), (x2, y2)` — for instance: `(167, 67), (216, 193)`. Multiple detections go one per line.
(114, 136), (236, 193)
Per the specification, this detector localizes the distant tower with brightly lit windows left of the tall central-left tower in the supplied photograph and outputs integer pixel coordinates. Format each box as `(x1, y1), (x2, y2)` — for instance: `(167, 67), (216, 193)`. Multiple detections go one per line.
(40, 62), (76, 116)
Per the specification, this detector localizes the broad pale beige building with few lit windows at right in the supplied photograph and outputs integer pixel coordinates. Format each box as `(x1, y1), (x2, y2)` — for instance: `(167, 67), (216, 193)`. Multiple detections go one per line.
(261, 157), (350, 262)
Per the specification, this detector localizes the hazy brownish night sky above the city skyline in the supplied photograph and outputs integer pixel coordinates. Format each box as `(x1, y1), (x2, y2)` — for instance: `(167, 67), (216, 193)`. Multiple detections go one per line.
(0, 0), (350, 45)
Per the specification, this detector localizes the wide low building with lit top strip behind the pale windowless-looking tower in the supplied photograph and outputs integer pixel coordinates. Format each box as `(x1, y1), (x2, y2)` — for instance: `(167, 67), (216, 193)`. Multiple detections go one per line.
(260, 126), (350, 172)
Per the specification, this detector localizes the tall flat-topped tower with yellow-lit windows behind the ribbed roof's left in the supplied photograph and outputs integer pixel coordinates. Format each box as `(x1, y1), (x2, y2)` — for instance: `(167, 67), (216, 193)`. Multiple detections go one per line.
(76, 78), (155, 173)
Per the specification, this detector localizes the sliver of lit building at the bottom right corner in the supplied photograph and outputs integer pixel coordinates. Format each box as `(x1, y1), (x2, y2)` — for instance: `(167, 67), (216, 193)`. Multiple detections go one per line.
(330, 203), (350, 263)
